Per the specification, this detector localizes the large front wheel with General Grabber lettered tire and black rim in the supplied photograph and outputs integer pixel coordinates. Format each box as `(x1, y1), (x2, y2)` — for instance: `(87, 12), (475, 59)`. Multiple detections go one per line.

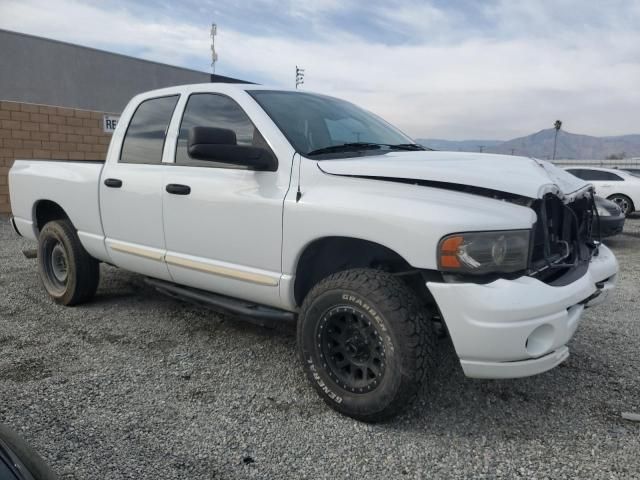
(298, 269), (435, 422)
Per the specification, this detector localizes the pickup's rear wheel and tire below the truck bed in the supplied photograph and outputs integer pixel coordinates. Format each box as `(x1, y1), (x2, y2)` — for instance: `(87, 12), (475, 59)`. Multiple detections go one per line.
(38, 220), (100, 306)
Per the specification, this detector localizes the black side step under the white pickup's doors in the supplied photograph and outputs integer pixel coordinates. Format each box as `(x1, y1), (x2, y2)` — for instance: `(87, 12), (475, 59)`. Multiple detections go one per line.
(145, 278), (296, 323)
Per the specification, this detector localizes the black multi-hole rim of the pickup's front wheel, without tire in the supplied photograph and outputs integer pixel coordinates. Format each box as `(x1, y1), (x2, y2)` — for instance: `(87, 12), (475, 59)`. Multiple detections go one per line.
(316, 306), (386, 393)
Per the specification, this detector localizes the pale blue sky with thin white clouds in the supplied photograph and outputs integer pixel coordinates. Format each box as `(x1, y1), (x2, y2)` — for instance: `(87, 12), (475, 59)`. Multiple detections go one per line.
(0, 0), (640, 140)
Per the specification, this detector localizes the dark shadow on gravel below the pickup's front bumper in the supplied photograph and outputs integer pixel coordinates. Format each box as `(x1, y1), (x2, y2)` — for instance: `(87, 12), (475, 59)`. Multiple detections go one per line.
(398, 339), (640, 442)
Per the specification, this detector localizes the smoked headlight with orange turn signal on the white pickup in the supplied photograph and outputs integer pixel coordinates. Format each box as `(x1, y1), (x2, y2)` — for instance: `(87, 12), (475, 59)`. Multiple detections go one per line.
(438, 230), (531, 274)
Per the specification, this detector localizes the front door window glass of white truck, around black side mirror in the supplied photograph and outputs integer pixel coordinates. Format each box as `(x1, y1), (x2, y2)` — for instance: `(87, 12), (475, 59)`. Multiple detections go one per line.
(176, 93), (269, 168)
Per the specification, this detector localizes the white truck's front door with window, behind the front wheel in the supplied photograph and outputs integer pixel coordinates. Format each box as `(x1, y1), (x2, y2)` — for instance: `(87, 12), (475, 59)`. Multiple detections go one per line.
(162, 93), (289, 305)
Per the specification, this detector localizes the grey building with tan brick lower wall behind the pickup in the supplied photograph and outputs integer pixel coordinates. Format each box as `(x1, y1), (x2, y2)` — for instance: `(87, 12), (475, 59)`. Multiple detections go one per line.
(0, 30), (247, 214)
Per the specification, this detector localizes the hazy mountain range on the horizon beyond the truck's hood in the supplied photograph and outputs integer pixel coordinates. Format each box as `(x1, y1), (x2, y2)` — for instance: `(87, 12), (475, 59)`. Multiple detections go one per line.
(416, 128), (640, 160)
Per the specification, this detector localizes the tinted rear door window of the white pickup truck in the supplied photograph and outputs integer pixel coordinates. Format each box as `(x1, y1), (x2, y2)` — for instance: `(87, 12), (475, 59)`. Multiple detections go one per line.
(120, 95), (178, 165)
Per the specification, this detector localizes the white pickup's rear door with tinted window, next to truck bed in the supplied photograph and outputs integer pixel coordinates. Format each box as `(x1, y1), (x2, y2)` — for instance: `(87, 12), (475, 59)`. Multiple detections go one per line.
(100, 95), (179, 280)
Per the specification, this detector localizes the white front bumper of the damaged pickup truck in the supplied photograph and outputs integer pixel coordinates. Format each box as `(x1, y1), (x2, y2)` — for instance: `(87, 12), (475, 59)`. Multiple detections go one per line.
(427, 245), (618, 378)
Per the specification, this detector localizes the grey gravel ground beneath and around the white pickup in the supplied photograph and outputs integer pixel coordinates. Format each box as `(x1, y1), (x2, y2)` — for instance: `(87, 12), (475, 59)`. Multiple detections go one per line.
(0, 217), (640, 479)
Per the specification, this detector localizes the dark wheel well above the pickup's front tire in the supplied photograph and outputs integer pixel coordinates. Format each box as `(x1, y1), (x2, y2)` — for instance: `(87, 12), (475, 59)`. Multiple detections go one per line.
(293, 237), (433, 305)
